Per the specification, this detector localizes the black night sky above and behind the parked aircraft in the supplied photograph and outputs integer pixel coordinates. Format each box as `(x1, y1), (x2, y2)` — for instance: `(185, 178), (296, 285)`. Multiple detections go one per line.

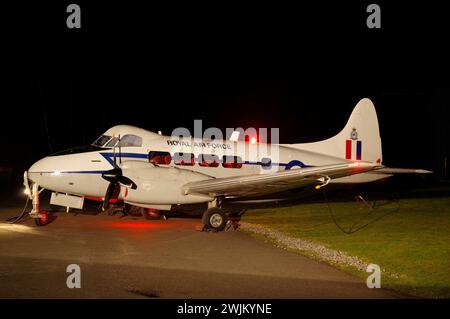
(0, 1), (450, 179)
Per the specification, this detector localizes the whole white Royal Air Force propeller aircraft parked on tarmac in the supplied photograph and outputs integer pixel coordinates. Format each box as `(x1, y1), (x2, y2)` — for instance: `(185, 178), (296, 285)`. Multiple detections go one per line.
(24, 99), (426, 230)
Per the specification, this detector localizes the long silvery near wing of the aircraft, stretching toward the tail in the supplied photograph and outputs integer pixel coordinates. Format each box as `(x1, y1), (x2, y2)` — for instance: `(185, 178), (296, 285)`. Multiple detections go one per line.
(183, 162), (382, 196)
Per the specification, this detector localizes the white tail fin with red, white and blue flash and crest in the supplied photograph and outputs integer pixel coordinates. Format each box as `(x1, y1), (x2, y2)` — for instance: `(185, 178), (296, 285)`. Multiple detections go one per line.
(292, 98), (382, 164)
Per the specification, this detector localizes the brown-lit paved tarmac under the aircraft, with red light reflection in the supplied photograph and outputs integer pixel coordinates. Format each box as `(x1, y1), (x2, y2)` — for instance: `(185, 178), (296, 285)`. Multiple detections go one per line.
(0, 206), (399, 298)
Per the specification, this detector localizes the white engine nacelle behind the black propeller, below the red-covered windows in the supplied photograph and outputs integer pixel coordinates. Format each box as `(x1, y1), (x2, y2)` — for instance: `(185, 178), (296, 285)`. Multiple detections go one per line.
(122, 161), (213, 205)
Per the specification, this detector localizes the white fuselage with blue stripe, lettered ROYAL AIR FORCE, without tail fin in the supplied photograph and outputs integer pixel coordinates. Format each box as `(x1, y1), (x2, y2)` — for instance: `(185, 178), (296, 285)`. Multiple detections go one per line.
(28, 125), (345, 204)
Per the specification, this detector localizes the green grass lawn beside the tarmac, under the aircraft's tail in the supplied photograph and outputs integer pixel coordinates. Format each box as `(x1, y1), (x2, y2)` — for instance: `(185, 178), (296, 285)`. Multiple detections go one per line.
(242, 197), (450, 298)
